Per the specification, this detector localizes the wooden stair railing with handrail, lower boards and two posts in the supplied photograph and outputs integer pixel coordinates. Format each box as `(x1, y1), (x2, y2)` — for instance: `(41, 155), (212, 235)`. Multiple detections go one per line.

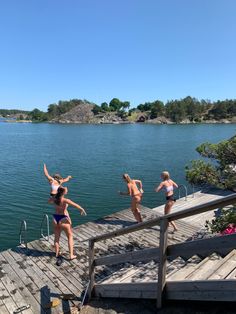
(89, 193), (236, 308)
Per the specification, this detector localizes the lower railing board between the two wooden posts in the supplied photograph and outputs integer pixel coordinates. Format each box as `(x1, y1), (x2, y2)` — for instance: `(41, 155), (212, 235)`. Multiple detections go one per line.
(94, 248), (159, 266)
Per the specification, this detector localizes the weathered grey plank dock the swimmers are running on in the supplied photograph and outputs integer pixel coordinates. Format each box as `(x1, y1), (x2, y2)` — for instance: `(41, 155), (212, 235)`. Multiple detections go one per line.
(0, 191), (236, 314)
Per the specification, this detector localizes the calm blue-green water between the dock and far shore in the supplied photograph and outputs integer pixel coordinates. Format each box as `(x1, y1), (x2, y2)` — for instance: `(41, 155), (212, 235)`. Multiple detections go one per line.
(0, 123), (236, 250)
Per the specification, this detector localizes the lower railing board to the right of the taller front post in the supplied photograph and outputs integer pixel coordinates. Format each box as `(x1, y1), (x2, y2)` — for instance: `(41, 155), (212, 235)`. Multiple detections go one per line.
(167, 233), (236, 258)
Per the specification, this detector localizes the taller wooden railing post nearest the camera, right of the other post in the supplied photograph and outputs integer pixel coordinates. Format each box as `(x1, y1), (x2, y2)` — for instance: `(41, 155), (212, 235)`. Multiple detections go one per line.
(157, 219), (169, 309)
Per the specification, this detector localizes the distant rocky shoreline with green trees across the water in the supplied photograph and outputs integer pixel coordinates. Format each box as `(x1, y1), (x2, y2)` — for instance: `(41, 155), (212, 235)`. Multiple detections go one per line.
(0, 96), (236, 124)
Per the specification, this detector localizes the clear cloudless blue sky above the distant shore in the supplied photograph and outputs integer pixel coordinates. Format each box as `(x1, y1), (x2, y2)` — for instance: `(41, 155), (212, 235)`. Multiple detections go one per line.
(0, 0), (236, 111)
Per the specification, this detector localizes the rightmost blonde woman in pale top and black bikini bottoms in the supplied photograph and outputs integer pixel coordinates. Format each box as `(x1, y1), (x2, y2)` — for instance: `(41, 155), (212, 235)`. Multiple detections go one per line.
(155, 171), (178, 231)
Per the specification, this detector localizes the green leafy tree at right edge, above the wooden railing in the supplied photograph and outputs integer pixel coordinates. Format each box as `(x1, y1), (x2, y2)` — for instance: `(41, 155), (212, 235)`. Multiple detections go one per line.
(186, 136), (236, 192)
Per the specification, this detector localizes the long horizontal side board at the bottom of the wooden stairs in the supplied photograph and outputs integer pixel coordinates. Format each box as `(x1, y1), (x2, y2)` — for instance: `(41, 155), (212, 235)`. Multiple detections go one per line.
(94, 280), (236, 302)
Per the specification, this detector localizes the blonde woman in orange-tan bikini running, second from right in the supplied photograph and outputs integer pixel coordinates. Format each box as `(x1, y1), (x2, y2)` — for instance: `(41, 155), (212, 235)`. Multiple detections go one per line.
(120, 173), (143, 222)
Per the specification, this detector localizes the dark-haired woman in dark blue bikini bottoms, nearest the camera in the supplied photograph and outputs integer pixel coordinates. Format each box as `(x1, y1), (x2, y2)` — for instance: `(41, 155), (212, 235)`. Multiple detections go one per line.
(49, 186), (87, 266)
